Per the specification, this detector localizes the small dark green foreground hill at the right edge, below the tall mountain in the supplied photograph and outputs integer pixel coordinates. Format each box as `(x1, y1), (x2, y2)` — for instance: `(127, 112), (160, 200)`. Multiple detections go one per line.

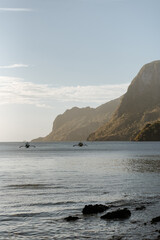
(134, 121), (160, 141)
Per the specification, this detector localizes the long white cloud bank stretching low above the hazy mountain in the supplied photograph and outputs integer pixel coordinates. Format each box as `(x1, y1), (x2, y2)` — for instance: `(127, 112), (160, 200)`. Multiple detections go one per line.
(0, 76), (129, 108)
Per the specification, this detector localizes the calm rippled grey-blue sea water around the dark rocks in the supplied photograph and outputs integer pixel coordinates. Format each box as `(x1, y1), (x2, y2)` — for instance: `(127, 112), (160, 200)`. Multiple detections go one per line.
(0, 142), (160, 240)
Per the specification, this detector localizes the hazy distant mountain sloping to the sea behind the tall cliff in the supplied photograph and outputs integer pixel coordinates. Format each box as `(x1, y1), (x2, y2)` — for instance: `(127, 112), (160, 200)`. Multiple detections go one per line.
(32, 98), (121, 142)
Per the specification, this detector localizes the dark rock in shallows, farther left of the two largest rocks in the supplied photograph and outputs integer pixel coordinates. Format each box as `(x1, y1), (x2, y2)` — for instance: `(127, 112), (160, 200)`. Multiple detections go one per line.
(82, 204), (109, 214)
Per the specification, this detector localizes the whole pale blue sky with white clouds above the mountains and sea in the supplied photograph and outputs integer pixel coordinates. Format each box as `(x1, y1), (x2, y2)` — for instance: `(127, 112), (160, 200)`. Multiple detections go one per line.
(0, 0), (160, 142)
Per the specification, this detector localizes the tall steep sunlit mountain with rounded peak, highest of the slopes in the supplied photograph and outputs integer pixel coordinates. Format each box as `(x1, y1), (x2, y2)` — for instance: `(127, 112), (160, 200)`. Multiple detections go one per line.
(88, 61), (160, 141)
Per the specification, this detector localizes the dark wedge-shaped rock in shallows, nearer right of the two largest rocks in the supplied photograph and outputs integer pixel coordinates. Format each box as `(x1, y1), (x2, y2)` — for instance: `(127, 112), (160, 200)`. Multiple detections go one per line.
(101, 208), (131, 219)
